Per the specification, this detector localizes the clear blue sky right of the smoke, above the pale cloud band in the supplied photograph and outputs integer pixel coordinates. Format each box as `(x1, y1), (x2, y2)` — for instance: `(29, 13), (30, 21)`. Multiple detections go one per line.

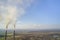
(21, 0), (60, 24)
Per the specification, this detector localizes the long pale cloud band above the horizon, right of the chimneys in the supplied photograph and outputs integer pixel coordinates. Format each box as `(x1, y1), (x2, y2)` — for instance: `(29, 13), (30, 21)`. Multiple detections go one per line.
(16, 22), (60, 30)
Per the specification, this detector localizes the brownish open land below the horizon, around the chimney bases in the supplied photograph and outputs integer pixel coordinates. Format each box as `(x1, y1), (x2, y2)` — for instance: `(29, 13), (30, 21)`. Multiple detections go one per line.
(0, 32), (60, 40)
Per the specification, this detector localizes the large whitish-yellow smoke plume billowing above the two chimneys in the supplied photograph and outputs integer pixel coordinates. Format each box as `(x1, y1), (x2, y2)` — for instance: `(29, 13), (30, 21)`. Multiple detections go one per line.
(0, 0), (33, 28)
